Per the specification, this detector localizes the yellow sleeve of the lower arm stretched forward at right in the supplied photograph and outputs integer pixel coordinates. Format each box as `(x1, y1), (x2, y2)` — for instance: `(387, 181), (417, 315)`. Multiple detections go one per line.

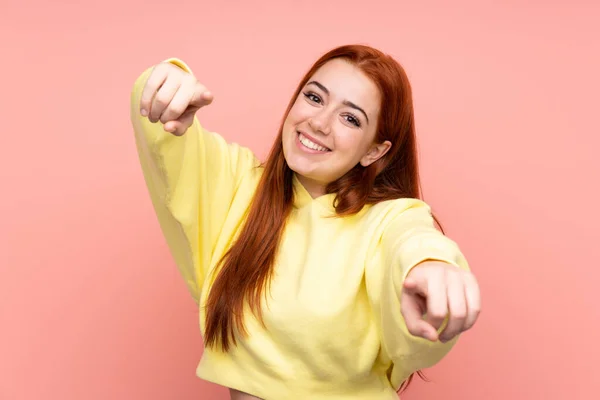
(366, 199), (469, 389)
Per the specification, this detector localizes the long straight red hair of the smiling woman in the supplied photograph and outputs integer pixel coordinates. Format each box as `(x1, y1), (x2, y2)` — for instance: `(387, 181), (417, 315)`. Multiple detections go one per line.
(205, 45), (438, 386)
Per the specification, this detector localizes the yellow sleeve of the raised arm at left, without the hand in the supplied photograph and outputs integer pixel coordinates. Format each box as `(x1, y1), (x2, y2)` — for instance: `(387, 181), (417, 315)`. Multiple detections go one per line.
(130, 58), (257, 303)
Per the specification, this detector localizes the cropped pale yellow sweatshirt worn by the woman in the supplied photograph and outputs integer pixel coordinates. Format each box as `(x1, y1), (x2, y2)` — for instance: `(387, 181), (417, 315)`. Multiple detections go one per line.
(131, 59), (469, 400)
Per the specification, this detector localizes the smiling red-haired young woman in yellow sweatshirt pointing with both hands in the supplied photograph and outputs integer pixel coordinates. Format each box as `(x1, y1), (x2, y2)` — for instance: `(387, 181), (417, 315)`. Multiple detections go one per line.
(131, 45), (480, 400)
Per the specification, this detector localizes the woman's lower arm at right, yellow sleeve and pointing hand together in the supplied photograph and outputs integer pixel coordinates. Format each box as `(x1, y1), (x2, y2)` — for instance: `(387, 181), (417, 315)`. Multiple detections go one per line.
(367, 199), (480, 386)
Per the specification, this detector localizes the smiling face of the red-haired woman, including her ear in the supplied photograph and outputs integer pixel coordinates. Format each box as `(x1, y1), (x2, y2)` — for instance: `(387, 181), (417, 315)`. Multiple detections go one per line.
(282, 59), (391, 197)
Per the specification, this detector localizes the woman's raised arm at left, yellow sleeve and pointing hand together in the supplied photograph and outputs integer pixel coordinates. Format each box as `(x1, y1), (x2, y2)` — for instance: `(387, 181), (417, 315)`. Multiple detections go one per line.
(130, 59), (257, 302)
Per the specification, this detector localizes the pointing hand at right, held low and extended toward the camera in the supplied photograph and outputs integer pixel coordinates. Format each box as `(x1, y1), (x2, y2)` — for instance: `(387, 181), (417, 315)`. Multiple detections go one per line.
(400, 261), (481, 342)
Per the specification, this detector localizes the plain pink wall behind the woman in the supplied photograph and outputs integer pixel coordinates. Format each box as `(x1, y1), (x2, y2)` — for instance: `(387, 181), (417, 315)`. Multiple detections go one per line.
(0, 0), (600, 400)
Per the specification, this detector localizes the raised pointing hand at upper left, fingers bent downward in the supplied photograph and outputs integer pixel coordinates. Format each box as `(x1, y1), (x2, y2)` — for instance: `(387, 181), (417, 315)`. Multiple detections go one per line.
(140, 62), (213, 136)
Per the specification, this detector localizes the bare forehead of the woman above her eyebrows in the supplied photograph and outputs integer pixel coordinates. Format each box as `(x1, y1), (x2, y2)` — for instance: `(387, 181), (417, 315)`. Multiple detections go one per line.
(309, 59), (380, 112)
